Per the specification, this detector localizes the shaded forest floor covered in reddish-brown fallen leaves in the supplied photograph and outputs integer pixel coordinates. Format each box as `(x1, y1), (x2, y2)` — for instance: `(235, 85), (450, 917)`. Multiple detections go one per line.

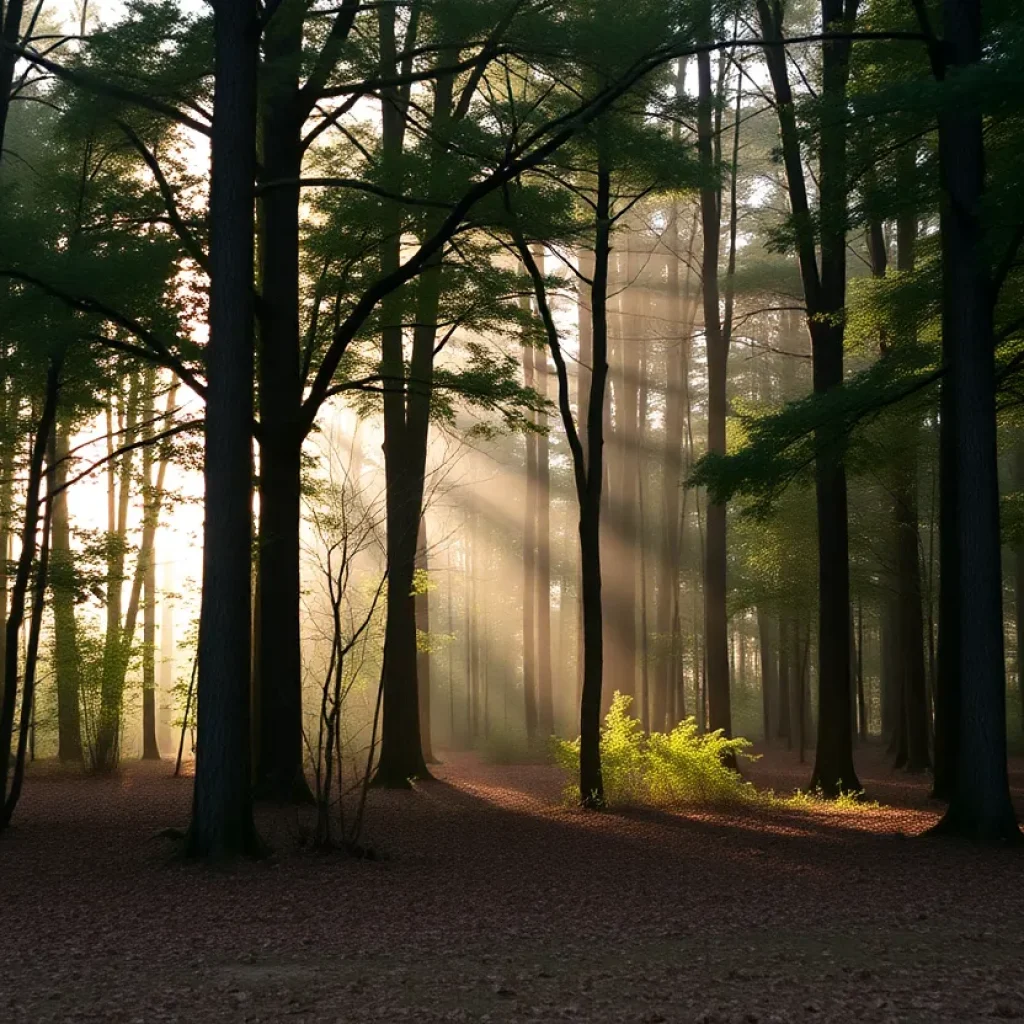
(0, 749), (1024, 1024)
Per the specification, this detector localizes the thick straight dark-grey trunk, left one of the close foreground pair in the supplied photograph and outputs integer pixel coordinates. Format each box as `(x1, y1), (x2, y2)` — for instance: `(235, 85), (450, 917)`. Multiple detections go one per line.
(186, 0), (260, 859)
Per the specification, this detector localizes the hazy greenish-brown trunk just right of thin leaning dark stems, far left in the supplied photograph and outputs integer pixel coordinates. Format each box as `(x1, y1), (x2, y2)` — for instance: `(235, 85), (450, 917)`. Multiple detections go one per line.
(50, 417), (83, 763)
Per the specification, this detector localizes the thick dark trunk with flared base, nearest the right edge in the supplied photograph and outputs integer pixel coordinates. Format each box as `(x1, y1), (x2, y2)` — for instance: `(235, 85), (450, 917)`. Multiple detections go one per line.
(933, 0), (1020, 841)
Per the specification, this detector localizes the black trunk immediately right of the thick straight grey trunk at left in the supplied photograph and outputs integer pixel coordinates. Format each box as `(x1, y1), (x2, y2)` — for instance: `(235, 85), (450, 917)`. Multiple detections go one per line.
(255, 0), (312, 803)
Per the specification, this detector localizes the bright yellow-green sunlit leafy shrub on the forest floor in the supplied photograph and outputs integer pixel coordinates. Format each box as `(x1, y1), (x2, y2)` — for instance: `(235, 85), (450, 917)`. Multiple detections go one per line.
(554, 691), (758, 806)
